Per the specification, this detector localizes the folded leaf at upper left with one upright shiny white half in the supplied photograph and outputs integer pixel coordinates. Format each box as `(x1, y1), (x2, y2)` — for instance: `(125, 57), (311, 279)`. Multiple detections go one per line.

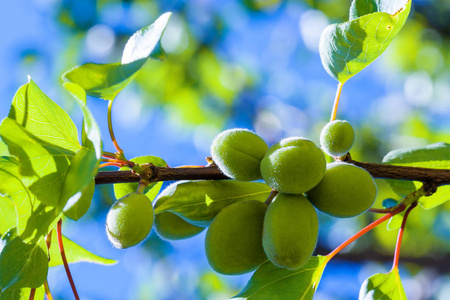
(63, 13), (171, 100)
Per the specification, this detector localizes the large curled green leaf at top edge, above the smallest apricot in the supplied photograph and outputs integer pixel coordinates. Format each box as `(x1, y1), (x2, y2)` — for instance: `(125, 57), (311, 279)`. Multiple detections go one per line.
(319, 0), (411, 83)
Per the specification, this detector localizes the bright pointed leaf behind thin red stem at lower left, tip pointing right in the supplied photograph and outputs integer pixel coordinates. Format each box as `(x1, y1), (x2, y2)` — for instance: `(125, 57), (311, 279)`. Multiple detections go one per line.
(49, 230), (116, 267)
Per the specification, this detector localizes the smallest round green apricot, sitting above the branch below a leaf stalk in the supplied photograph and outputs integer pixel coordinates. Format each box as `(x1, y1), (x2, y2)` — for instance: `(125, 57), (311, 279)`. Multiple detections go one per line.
(320, 120), (355, 156)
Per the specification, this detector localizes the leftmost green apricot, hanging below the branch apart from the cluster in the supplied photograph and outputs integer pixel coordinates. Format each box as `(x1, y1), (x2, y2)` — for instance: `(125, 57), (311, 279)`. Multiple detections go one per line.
(106, 193), (154, 249)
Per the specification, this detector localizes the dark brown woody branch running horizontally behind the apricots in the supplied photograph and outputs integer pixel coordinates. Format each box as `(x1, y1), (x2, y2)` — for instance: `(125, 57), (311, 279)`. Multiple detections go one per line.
(95, 159), (450, 187)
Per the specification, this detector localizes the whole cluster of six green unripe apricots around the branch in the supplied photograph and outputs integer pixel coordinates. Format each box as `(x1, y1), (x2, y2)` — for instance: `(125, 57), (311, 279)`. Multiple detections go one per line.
(205, 121), (377, 274)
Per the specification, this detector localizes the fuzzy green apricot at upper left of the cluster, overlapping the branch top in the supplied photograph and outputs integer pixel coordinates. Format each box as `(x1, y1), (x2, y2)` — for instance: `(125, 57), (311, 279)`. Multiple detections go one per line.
(211, 129), (269, 181)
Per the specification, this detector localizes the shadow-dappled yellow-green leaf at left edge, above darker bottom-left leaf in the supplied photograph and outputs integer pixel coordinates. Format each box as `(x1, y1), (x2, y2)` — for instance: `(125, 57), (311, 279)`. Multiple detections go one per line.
(0, 157), (61, 243)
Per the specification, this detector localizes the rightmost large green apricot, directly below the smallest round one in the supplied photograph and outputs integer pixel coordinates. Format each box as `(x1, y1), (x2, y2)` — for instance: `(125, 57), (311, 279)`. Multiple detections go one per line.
(306, 162), (377, 218)
